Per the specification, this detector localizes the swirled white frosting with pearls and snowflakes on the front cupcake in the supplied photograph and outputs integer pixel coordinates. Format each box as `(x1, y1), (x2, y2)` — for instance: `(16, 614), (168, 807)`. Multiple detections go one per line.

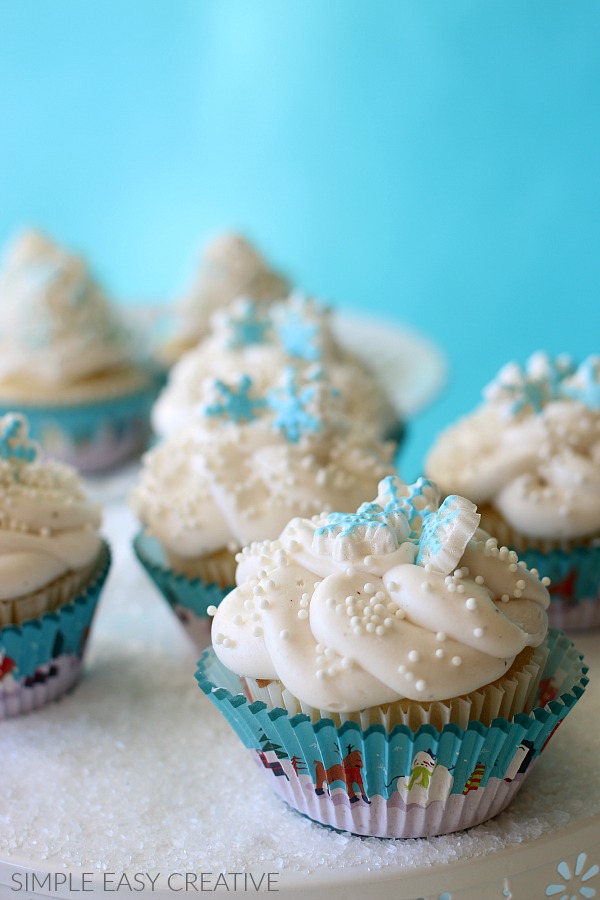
(212, 476), (549, 712)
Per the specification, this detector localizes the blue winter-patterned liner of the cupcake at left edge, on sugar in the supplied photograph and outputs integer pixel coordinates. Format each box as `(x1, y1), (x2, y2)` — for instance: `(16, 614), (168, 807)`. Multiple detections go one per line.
(0, 544), (111, 719)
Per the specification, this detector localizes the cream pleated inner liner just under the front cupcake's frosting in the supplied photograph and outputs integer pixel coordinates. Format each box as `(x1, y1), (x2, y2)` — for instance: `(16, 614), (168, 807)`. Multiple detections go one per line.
(241, 644), (549, 731)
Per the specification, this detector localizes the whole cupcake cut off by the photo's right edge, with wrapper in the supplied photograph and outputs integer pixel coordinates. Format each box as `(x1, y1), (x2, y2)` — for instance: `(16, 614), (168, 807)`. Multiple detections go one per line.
(426, 353), (600, 629)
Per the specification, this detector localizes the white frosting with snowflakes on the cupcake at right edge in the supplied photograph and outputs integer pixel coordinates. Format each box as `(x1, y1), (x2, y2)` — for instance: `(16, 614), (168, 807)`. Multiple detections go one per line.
(426, 353), (600, 540)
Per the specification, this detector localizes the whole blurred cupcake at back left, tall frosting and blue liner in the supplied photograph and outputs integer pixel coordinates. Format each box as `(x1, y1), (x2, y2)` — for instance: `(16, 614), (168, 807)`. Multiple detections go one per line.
(0, 231), (156, 472)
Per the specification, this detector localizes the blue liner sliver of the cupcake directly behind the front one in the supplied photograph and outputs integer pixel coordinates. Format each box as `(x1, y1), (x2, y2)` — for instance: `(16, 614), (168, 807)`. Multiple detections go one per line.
(133, 531), (233, 650)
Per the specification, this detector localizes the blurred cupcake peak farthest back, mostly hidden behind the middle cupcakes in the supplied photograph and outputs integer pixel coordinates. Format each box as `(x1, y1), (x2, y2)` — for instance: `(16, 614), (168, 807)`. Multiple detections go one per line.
(159, 233), (290, 365)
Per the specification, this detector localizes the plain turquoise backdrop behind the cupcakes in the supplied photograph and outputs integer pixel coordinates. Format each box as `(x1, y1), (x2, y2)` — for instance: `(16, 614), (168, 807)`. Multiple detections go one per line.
(0, 0), (600, 477)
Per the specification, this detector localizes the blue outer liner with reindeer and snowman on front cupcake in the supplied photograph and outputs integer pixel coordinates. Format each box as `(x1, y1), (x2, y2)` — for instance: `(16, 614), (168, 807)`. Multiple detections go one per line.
(196, 630), (588, 838)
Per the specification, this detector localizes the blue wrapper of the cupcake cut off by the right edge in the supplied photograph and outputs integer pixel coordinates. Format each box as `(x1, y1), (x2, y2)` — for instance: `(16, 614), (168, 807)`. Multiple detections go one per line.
(519, 546), (600, 630)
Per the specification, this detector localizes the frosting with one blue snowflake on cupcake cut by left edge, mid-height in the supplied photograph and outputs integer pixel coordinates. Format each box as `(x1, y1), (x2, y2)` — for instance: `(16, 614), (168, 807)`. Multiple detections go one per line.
(0, 413), (100, 599)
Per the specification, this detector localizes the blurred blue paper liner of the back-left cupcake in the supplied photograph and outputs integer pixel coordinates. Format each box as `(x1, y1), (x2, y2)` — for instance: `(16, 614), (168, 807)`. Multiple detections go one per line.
(0, 381), (156, 473)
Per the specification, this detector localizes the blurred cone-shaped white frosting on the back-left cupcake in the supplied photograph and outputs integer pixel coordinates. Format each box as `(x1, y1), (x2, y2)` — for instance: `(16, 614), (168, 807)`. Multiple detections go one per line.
(0, 231), (132, 388)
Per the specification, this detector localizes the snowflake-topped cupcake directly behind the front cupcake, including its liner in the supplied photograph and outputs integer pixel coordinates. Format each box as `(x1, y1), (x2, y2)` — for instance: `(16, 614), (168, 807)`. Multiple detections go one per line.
(132, 368), (393, 641)
